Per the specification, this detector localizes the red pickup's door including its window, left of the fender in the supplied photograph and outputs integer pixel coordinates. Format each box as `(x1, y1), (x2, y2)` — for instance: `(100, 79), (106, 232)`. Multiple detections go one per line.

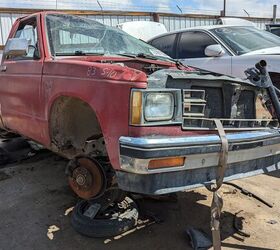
(0, 15), (44, 141)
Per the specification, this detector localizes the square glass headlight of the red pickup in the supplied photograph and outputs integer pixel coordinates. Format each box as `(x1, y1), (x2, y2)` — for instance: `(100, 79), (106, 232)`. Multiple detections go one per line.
(144, 93), (174, 121)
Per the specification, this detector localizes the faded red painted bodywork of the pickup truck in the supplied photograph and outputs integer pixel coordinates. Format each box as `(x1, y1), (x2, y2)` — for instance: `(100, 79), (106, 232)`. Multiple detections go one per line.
(0, 12), (194, 169)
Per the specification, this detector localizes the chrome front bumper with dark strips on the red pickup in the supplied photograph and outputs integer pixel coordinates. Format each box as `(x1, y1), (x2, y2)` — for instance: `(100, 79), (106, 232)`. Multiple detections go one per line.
(117, 129), (280, 194)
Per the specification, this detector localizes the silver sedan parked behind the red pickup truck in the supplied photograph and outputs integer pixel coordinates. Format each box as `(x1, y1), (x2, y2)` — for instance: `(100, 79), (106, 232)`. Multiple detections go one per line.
(149, 25), (280, 88)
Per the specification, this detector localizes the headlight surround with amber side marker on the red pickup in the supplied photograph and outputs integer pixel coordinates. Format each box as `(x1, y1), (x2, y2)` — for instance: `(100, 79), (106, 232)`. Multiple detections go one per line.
(130, 89), (182, 126)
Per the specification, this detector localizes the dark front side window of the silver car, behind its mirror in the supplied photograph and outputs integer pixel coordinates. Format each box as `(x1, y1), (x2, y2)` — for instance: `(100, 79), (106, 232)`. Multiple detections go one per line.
(177, 31), (217, 59)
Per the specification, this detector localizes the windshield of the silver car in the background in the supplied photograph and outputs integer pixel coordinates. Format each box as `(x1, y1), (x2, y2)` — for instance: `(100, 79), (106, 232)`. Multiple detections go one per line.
(211, 27), (280, 55)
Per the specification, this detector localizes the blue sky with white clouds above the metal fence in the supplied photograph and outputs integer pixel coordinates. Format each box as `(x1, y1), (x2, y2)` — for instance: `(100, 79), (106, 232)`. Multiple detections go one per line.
(0, 0), (280, 17)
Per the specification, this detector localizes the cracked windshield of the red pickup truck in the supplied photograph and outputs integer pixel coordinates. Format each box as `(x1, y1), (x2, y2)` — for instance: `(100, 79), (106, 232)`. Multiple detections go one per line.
(46, 14), (170, 60)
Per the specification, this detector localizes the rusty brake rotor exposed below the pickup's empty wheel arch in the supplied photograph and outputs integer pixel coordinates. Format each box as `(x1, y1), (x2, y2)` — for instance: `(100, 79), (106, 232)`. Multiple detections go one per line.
(68, 157), (106, 200)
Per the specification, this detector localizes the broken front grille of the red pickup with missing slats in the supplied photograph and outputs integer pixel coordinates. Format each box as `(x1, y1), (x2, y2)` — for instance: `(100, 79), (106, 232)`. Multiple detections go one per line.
(182, 86), (277, 130)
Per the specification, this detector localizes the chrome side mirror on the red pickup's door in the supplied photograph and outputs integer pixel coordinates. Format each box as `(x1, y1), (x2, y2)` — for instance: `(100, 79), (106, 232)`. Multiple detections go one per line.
(3, 38), (29, 56)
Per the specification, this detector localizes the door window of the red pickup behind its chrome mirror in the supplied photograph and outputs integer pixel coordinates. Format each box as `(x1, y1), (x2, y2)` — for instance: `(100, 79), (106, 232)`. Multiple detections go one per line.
(9, 18), (39, 60)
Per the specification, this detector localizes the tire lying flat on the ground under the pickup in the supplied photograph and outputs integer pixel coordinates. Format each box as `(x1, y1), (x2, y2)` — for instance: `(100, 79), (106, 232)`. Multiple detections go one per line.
(71, 197), (138, 238)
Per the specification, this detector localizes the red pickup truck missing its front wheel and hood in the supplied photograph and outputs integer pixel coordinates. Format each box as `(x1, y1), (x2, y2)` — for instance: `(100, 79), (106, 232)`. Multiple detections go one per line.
(0, 12), (280, 199)
